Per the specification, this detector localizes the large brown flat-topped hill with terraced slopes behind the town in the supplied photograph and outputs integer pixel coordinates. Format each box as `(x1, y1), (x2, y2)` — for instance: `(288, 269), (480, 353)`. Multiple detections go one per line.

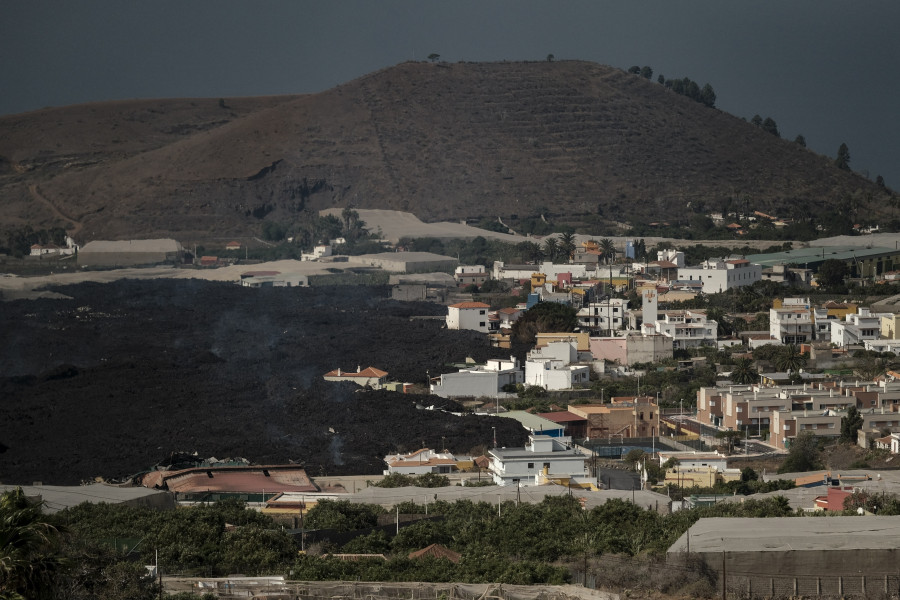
(0, 61), (894, 242)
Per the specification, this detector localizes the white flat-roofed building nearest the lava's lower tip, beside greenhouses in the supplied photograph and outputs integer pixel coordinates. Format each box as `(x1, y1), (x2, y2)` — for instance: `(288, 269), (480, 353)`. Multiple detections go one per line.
(488, 435), (586, 485)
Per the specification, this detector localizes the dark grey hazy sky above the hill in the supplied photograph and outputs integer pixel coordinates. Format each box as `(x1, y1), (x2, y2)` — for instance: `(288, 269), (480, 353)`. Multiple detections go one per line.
(0, 0), (900, 189)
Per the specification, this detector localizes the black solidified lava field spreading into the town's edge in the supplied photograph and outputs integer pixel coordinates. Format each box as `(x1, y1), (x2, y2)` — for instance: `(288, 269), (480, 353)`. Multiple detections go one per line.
(0, 280), (525, 484)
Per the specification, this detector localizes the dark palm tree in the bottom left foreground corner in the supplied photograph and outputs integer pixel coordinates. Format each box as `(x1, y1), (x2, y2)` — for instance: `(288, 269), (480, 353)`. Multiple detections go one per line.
(0, 488), (63, 599)
